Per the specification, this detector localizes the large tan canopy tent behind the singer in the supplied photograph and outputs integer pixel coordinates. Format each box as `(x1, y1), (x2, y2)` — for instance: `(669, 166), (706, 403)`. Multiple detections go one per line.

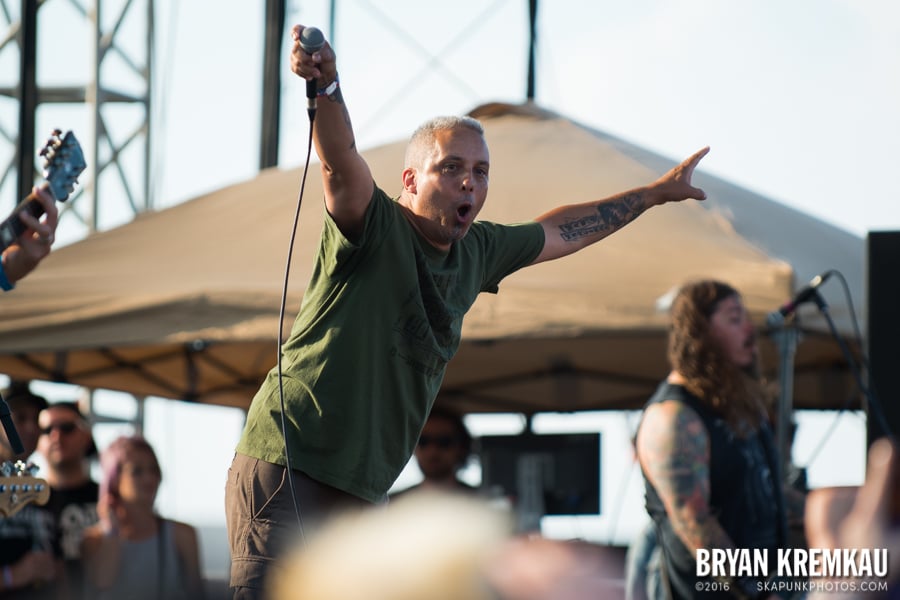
(0, 105), (863, 412)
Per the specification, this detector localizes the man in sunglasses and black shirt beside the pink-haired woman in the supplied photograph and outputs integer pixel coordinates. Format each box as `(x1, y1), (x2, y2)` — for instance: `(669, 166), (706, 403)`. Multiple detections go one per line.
(38, 402), (100, 598)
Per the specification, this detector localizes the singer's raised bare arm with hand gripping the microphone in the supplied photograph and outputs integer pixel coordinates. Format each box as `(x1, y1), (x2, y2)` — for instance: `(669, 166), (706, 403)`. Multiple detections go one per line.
(291, 25), (375, 239)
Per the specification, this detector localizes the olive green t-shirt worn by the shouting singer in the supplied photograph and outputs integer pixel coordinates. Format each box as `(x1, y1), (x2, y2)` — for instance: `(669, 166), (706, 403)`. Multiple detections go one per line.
(237, 187), (544, 502)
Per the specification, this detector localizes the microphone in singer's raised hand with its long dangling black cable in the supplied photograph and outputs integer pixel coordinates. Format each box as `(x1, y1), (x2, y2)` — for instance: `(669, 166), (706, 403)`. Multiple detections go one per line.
(276, 27), (325, 540)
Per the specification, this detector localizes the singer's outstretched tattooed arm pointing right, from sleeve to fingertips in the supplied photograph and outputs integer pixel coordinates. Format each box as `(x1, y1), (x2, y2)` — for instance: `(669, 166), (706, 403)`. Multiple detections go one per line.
(534, 147), (709, 263)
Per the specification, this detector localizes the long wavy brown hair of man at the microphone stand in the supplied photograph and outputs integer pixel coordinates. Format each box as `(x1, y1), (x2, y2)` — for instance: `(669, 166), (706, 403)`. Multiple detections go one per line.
(669, 280), (765, 436)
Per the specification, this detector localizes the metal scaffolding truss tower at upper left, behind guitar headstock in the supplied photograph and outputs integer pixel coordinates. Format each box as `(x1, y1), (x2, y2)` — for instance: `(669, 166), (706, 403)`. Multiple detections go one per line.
(0, 0), (154, 241)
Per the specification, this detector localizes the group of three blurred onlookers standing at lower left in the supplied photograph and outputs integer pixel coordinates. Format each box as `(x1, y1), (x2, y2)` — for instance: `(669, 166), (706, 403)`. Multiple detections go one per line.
(0, 382), (204, 600)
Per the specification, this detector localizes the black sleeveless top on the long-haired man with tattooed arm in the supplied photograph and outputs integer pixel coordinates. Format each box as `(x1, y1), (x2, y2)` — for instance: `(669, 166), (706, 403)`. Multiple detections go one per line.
(644, 382), (787, 599)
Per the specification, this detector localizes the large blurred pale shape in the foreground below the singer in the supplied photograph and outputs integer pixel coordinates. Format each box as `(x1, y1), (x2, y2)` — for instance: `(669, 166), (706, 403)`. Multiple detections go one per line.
(270, 491), (621, 600)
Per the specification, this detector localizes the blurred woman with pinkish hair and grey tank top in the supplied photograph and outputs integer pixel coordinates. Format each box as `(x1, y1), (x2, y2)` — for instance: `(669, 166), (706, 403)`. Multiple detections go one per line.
(82, 436), (203, 600)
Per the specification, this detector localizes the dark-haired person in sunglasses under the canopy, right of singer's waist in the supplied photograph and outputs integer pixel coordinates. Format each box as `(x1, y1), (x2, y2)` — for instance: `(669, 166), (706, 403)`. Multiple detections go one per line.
(392, 408), (478, 499)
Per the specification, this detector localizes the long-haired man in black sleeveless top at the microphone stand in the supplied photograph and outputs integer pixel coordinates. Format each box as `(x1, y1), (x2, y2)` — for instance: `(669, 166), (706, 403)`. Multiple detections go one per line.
(637, 280), (802, 599)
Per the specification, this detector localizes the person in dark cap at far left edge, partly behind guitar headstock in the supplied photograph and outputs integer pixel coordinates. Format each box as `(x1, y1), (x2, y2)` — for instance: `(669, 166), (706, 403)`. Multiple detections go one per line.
(0, 382), (59, 600)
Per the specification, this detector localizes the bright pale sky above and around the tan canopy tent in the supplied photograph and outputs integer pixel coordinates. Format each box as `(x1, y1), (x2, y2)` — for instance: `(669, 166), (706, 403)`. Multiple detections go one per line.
(8, 0), (900, 572)
